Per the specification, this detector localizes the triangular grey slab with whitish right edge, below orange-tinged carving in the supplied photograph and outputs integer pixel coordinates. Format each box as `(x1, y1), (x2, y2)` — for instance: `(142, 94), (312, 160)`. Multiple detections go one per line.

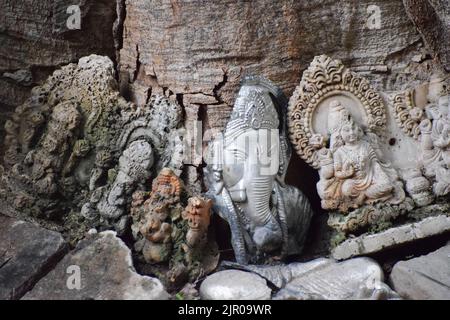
(23, 231), (169, 300)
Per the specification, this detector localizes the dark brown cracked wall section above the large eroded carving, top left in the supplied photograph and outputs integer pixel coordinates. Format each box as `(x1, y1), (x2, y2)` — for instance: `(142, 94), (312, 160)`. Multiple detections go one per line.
(0, 0), (117, 106)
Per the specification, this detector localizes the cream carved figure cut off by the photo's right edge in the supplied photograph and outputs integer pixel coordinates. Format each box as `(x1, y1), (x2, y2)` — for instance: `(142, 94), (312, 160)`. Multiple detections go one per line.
(393, 74), (450, 199)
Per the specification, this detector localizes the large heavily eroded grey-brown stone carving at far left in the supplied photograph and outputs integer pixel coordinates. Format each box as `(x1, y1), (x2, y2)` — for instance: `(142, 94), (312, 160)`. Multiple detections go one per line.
(0, 55), (184, 240)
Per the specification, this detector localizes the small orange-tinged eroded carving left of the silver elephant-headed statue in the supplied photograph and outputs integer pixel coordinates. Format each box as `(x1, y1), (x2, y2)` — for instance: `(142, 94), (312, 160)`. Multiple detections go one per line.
(131, 168), (219, 287)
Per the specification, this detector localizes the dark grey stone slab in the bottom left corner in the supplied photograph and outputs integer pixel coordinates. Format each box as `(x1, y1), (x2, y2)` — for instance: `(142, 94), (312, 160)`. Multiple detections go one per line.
(0, 215), (67, 300)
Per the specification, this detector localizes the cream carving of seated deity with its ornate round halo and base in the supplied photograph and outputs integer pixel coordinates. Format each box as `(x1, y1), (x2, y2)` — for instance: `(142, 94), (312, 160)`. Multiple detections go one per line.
(289, 56), (414, 233)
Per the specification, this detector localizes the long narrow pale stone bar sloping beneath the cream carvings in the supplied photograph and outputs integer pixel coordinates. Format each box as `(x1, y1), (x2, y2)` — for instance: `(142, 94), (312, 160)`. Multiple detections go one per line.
(332, 215), (450, 260)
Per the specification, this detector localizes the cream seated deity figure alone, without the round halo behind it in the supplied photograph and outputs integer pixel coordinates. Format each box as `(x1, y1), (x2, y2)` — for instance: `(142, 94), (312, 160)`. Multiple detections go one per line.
(317, 100), (405, 212)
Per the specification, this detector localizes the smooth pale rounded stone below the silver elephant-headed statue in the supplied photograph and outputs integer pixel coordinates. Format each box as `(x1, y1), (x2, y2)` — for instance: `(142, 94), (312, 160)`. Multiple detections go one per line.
(200, 270), (272, 300)
